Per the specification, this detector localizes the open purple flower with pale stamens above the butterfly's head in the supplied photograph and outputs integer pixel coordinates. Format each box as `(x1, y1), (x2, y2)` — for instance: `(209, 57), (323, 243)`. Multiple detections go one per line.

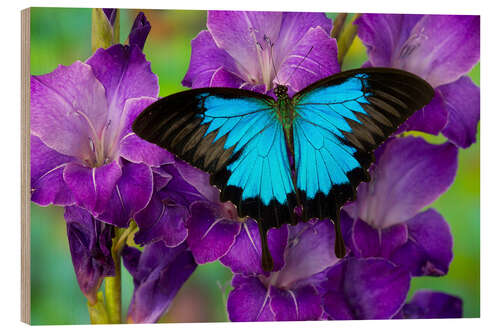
(182, 11), (340, 94)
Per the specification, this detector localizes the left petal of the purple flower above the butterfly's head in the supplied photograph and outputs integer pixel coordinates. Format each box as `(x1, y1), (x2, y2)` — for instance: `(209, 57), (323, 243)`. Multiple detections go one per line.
(182, 30), (243, 88)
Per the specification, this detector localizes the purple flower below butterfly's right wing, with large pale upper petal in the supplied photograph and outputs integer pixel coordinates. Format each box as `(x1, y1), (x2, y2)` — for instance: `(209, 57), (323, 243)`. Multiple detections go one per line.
(341, 137), (458, 276)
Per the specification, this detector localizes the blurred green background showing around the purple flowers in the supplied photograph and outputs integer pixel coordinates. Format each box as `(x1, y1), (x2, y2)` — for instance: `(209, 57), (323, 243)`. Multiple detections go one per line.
(31, 8), (479, 325)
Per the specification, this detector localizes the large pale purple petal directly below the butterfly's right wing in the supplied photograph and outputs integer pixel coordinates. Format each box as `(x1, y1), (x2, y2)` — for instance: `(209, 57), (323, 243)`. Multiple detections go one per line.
(344, 137), (458, 229)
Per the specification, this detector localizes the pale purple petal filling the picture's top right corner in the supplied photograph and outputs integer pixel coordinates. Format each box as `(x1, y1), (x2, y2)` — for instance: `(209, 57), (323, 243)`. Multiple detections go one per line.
(393, 15), (479, 87)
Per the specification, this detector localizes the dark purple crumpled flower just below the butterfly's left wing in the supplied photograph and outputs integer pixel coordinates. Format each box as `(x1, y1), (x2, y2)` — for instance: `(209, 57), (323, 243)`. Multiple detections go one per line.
(135, 159), (241, 264)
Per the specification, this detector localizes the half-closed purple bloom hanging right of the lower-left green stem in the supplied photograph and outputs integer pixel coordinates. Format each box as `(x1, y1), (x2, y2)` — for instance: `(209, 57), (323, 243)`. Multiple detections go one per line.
(123, 242), (196, 323)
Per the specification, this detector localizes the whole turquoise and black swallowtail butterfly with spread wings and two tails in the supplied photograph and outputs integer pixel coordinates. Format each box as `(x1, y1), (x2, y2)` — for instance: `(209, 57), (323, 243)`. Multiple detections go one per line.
(132, 68), (434, 271)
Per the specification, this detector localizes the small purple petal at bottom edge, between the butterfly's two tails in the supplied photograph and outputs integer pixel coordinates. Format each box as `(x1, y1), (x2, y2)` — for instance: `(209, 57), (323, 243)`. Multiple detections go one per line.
(270, 285), (323, 321)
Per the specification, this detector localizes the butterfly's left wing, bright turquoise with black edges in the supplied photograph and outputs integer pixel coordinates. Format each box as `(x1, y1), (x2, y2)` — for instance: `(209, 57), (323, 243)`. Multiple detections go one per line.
(133, 88), (296, 268)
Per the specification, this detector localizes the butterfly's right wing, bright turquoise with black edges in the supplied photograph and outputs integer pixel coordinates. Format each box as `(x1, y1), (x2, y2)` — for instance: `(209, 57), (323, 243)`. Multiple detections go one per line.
(293, 68), (434, 220)
